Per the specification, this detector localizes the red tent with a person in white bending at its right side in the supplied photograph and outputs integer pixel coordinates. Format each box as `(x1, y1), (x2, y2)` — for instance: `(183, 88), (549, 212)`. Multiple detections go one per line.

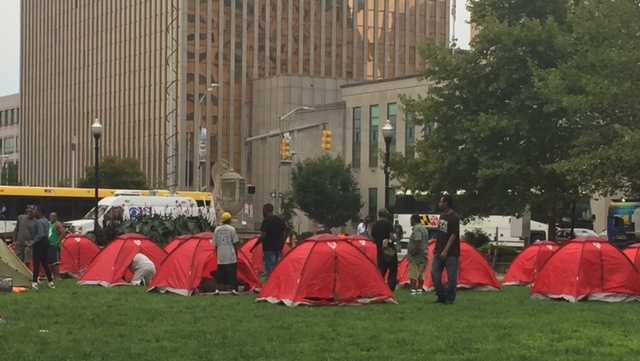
(78, 234), (167, 287)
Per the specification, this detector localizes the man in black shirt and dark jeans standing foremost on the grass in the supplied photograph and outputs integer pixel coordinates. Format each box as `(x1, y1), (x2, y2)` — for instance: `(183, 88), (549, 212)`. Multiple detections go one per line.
(431, 194), (460, 304)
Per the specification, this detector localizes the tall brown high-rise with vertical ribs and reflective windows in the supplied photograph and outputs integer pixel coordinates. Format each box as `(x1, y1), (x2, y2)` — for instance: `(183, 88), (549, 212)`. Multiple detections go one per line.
(21, 0), (450, 188)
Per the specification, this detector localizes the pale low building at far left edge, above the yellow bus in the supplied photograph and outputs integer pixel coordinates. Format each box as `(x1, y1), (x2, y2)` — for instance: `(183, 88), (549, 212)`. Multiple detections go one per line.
(0, 94), (20, 185)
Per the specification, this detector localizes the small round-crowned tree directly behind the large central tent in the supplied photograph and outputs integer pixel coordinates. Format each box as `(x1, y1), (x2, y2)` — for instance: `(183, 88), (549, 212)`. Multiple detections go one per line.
(291, 155), (362, 228)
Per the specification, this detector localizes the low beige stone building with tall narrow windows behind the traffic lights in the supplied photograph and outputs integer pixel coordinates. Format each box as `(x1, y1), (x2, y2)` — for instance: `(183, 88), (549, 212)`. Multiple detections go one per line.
(247, 75), (428, 230)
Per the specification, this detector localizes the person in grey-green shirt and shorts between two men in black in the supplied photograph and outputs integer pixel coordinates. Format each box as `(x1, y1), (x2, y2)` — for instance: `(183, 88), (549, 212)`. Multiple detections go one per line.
(407, 214), (429, 295)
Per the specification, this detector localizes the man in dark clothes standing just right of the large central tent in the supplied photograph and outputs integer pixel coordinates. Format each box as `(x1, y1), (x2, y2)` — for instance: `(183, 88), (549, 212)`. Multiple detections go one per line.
(371, 209), (398, 291)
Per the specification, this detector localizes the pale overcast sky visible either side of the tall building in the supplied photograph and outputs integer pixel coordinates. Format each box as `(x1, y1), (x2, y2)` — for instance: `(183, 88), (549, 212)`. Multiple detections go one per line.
(0, 0), (469, 96)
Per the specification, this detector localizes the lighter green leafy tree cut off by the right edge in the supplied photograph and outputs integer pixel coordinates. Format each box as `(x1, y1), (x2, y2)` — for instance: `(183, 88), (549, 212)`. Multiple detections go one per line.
(537, 0), (640, 197)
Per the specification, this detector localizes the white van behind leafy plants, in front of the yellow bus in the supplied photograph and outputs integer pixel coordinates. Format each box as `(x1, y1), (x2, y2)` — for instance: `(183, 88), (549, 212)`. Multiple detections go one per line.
(64, 193), (208, 234)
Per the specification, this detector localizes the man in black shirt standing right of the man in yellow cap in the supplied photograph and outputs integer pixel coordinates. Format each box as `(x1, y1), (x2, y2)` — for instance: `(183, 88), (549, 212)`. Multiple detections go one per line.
(258, 203), (287, 279)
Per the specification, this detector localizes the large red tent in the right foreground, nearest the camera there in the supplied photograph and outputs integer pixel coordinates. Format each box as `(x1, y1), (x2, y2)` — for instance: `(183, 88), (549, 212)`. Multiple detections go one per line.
(531, 238), (640, 302)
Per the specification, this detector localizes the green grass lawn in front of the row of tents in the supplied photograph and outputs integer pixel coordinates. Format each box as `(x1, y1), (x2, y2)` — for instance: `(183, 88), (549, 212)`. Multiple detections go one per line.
(0, 281), (640, 361)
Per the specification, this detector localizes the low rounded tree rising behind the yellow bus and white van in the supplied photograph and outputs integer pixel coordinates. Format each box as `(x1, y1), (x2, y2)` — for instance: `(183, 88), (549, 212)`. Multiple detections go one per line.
(79, 157), (147, 189)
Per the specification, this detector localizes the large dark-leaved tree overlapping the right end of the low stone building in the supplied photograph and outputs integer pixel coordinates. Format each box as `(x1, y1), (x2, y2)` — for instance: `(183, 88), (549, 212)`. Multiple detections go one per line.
(393, 0), (578, 237)
